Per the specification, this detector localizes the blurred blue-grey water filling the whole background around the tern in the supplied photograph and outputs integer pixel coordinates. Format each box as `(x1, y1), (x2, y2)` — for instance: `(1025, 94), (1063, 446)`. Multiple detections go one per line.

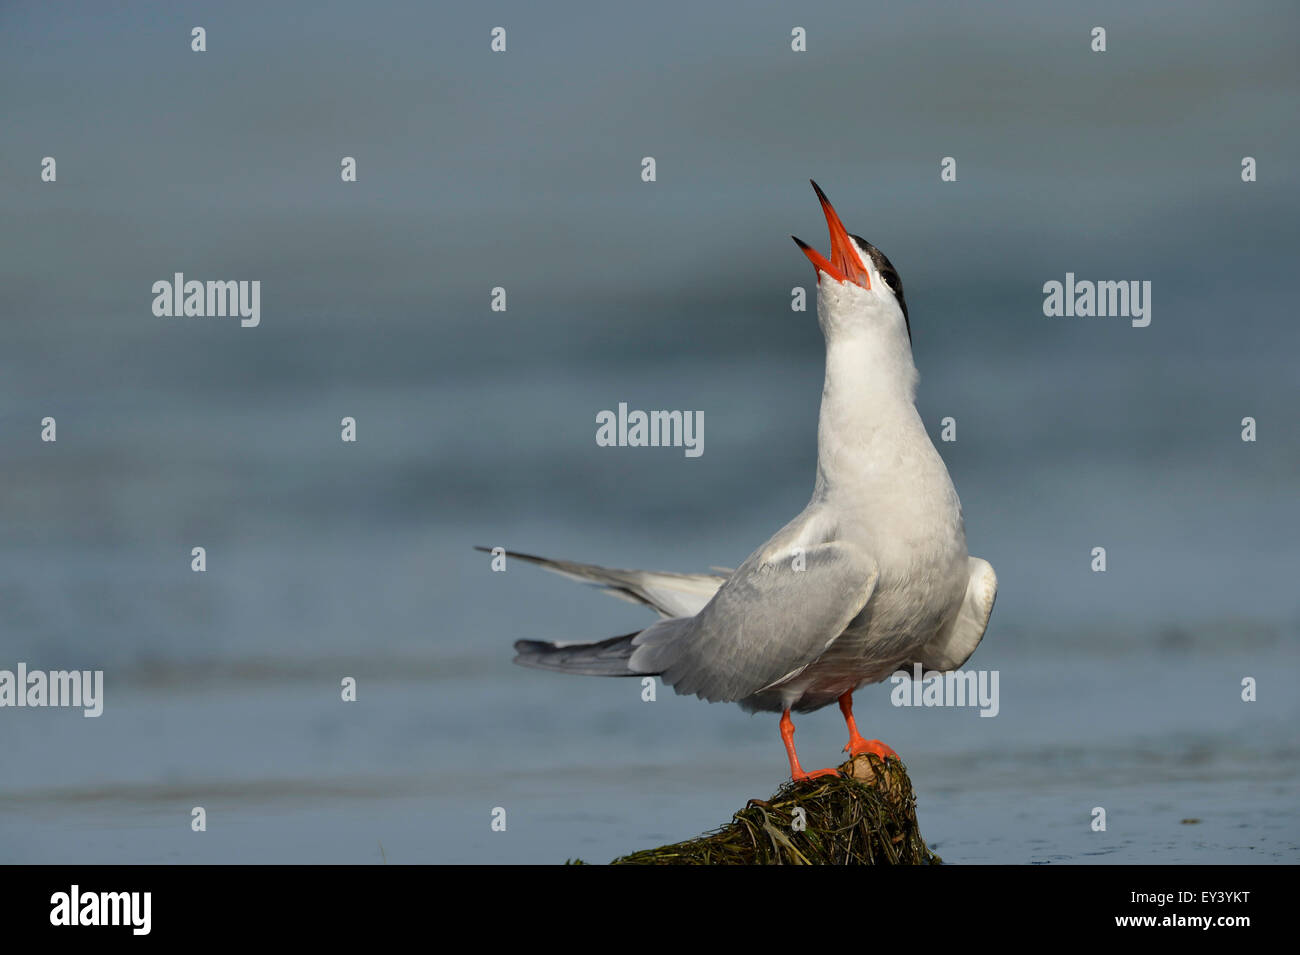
(0, 4), (1300, 863)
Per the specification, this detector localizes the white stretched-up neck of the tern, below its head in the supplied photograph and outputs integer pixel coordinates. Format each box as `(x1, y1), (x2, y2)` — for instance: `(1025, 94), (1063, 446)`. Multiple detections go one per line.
(818, 334), (928, 491)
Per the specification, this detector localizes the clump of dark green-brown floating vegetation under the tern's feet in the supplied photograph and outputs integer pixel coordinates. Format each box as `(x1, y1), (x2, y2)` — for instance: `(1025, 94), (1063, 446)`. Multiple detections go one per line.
(612, 755), (943, 865)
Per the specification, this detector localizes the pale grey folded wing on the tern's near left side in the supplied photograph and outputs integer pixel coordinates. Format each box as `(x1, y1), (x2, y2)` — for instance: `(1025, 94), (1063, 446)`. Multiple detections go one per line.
(631, 541), (879, 702)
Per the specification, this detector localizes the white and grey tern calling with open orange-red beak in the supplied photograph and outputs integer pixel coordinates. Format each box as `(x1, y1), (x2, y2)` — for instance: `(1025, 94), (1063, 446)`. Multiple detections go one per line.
(493, 182), (997, 781)
